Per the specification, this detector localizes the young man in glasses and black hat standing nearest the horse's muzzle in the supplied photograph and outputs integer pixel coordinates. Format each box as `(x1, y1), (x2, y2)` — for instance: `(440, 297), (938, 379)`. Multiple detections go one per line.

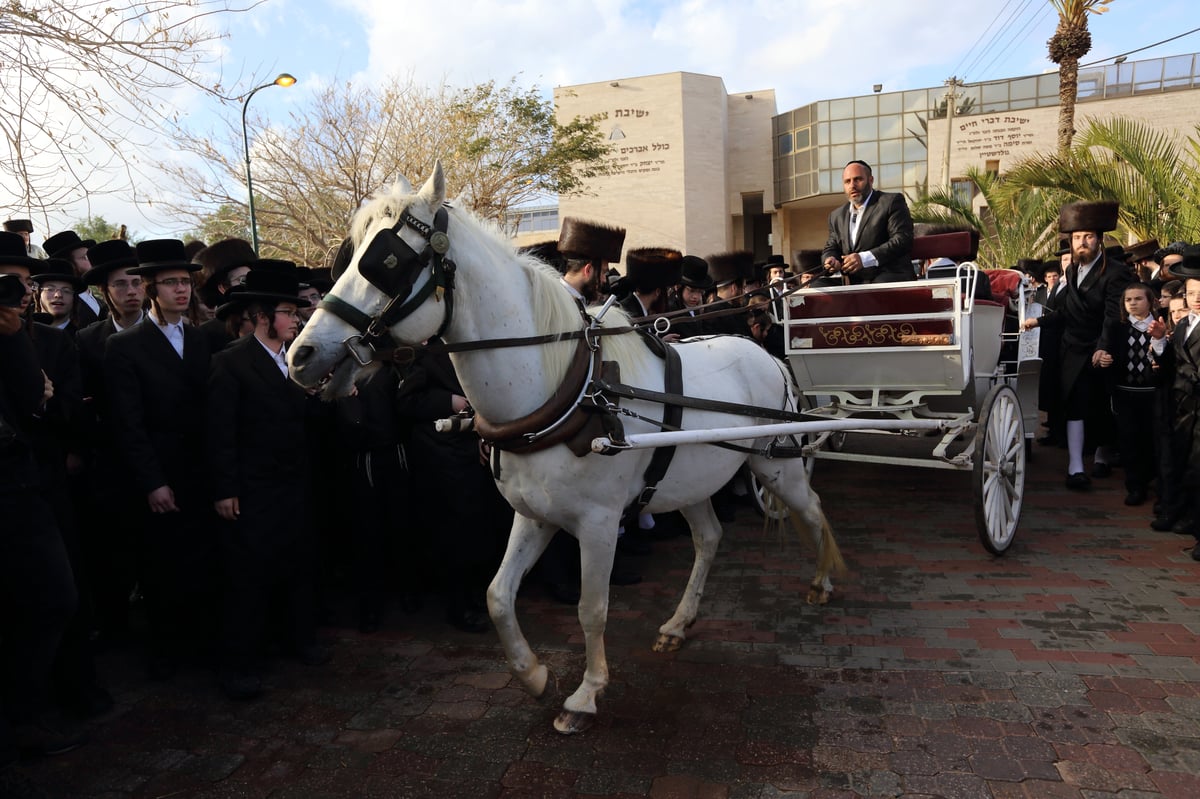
(208, 259), (329, 699)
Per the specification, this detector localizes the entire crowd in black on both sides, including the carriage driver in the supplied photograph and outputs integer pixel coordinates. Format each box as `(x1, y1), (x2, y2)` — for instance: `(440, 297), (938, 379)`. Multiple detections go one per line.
(0, 172), (1200, 791)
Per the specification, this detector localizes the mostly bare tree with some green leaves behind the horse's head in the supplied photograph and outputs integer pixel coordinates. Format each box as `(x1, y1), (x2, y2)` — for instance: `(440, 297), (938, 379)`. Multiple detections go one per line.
(160, 74), (611, 265)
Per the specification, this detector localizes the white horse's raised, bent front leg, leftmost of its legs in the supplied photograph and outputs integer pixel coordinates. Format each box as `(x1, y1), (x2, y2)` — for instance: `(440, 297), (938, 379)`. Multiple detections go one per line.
(487, 513), (557, 697)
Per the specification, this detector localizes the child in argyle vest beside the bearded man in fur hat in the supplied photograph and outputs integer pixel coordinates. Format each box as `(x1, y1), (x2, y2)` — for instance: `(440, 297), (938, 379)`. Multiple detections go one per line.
(1099, 283), (1166, 505)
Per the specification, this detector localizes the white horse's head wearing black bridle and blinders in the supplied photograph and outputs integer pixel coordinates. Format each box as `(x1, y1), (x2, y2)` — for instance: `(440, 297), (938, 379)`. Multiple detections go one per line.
(288, 162), (455, 398)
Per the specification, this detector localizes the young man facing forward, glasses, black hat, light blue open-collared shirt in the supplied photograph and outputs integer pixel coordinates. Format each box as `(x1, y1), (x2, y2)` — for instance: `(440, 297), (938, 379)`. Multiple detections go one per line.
(104, 239), (214, 679)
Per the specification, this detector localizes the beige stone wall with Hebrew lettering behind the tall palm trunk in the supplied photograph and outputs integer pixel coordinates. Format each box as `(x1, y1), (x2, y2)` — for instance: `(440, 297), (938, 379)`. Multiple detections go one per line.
(929, 89), (1200, 179)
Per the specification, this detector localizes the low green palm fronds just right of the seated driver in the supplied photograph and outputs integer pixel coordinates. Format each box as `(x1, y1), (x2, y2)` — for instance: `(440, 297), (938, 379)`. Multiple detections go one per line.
(912, 167), (1062, 269)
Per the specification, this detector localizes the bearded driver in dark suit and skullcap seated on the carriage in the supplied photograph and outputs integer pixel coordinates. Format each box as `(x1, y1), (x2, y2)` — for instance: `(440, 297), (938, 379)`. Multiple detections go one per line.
(821, 161), (914, 286)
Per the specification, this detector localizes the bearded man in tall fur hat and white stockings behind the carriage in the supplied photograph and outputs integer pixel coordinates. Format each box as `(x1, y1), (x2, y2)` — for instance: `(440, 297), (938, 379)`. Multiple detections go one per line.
(1021, 202), (1132, 491)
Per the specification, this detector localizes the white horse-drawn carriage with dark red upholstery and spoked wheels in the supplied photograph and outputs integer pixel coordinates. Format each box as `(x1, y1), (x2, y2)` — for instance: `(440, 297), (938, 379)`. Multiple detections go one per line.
(784, 234), (1040, 554)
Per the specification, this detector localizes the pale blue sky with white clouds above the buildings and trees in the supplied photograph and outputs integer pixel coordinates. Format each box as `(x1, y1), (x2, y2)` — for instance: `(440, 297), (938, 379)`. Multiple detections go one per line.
(0, 0), (1200, 240)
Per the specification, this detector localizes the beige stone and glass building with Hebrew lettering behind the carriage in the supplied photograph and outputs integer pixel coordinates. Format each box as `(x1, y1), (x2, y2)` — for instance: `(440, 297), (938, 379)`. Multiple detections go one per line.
(532, 55), (1200, 271)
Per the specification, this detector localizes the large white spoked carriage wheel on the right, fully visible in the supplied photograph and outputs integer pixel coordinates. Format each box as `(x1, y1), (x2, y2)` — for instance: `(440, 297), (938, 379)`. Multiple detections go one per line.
(973, 384), (1025, 554)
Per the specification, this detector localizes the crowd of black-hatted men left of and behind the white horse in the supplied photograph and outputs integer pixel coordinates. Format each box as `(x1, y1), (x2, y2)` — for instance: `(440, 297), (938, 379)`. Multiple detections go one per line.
(0, 209), (785, 782)
